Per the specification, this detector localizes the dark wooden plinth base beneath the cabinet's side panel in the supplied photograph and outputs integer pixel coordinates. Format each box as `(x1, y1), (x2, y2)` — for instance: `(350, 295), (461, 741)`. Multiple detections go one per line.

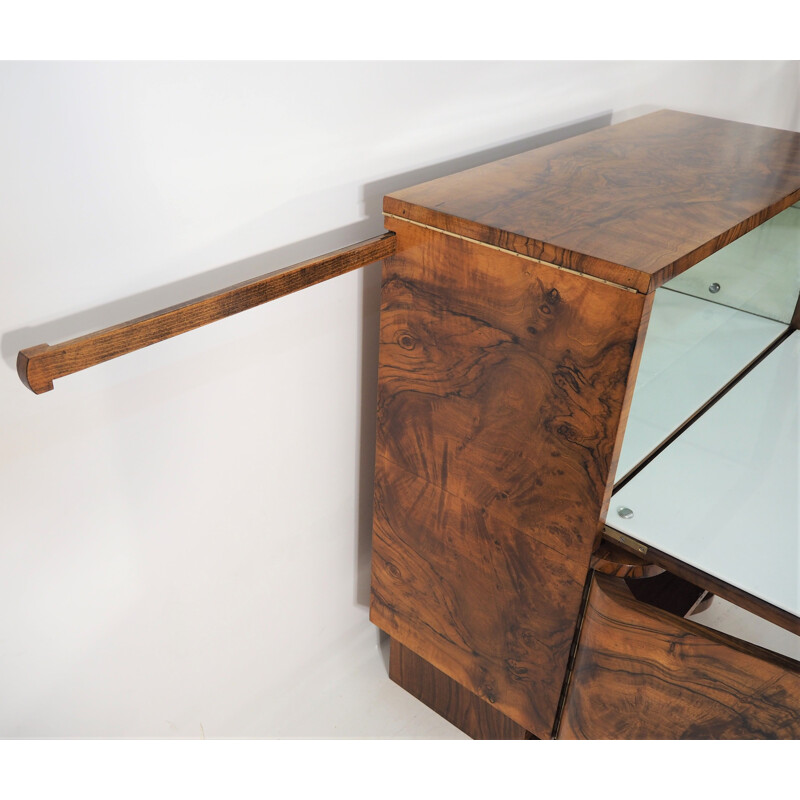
(389, 639), (536, 739)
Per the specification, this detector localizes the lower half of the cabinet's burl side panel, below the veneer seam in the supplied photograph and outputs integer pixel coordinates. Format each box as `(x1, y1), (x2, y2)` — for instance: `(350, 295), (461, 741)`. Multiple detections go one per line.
(370, 456), (586, 738)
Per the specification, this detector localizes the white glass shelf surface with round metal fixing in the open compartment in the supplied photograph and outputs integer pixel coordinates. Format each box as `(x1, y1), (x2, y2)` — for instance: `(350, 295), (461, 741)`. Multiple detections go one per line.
(608, 332), (800, 616)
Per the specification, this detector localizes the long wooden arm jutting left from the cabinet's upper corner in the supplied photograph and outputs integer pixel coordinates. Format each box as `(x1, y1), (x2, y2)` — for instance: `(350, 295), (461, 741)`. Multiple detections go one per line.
(17, 232), (395, 394)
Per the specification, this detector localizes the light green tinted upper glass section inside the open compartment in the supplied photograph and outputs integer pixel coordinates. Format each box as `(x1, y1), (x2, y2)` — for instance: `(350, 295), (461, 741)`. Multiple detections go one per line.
(664, 204), (800, 323)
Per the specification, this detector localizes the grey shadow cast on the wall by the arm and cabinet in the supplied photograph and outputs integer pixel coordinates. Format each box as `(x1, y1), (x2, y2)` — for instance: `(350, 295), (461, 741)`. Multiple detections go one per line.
(0, 111), (611, 606)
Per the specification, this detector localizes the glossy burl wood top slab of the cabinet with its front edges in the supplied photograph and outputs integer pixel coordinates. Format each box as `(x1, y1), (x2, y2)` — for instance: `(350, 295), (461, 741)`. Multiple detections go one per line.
(384, 111), (800, 292)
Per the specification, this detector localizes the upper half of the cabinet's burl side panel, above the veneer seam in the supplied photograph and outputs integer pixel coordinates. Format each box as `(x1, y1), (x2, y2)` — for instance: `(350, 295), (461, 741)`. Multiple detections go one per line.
(377, 216), (652, 566)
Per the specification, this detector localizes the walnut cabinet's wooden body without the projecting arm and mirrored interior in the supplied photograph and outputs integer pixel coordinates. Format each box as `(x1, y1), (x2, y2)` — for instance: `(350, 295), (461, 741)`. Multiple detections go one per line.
(371, 111), (800, 738)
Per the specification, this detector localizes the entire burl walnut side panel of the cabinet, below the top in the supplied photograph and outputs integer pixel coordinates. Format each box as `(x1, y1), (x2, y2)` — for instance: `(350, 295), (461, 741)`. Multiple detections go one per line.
(371, 220), (652, 738)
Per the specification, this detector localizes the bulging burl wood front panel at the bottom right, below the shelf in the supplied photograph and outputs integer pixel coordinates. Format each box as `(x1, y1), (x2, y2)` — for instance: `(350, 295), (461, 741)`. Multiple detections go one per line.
(559, 575), (800, 739)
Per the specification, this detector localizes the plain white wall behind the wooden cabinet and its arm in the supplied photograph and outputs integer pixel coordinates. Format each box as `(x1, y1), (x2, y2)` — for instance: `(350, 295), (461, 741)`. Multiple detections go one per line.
(0, 62), (800, 737)
